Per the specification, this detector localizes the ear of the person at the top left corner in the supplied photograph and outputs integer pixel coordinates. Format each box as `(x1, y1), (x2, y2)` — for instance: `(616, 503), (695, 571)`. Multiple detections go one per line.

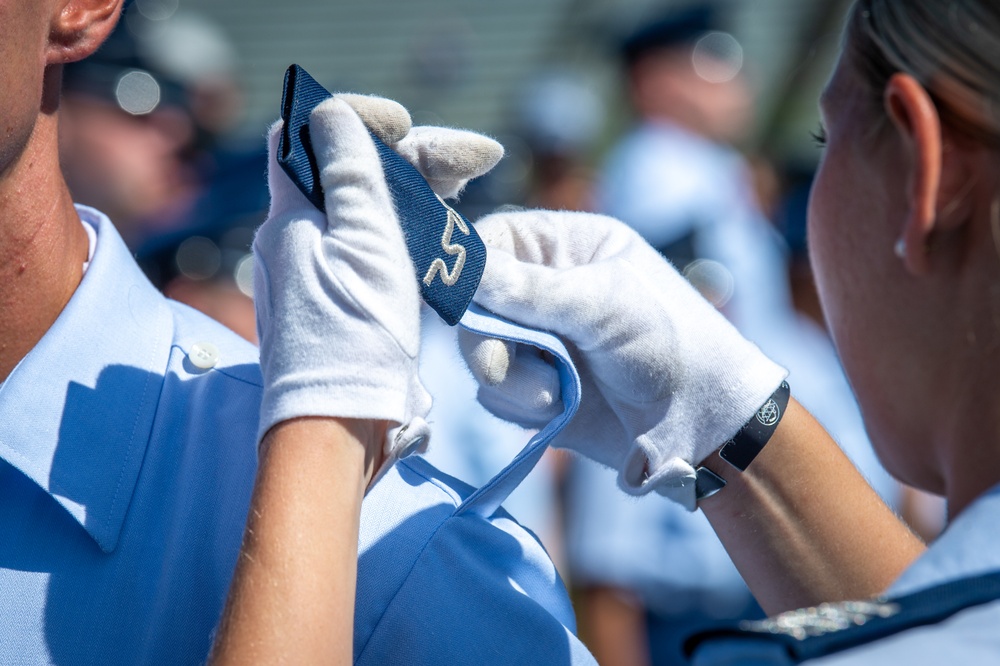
(47, 0), (124, 65)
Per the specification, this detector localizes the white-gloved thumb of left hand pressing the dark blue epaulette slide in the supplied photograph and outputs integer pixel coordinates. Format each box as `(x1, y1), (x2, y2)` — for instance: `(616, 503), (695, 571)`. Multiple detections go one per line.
(309, 98), (419, 356)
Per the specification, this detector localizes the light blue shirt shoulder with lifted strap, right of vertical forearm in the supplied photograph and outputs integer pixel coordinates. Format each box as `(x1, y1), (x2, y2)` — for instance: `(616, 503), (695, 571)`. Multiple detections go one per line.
(354, 306), (596, 666)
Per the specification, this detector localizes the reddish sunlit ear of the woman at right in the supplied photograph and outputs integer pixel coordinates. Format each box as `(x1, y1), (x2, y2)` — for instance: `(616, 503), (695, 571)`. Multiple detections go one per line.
(885, 73), (943, 275)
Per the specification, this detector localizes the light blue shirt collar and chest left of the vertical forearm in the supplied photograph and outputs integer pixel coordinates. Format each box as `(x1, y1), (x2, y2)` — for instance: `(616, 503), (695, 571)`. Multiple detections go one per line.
(0, 207), (261, 664)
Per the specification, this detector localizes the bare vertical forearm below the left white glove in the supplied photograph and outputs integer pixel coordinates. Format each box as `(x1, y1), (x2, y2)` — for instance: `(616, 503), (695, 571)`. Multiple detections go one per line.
(211, 418), (384, 664)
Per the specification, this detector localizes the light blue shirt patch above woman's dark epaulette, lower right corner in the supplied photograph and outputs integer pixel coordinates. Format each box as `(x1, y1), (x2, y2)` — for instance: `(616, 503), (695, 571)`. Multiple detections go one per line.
(888, 485), (1000, 596)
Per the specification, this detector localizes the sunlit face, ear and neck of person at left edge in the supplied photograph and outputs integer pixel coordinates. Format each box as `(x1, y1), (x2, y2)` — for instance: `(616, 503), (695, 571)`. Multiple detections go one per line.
(0, 0), (120, 380)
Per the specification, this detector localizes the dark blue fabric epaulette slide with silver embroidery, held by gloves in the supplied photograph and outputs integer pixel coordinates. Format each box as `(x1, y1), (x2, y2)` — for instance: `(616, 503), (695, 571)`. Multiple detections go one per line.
(278, 65), (486, 326)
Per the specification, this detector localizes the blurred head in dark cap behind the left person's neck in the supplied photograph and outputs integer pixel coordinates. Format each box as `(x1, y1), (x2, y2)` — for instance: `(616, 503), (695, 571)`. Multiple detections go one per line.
(59, 14), (200, 249)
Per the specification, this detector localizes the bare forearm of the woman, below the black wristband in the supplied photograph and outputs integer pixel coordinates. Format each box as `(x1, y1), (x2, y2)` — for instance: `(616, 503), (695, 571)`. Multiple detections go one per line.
(701, 400), (924, 614)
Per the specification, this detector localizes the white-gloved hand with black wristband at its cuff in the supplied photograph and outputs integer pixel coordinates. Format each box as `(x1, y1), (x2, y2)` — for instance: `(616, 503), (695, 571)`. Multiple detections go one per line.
(460, 211), (787, 511)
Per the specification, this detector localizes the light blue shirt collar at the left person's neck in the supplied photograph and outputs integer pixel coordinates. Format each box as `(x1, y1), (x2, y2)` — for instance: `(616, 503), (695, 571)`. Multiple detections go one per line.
(0, 206), (173, 552)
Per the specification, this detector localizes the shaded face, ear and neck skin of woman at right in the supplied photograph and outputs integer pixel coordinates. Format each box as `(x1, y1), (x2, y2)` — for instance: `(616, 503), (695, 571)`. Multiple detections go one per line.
(809, 50), (1000, 516)
